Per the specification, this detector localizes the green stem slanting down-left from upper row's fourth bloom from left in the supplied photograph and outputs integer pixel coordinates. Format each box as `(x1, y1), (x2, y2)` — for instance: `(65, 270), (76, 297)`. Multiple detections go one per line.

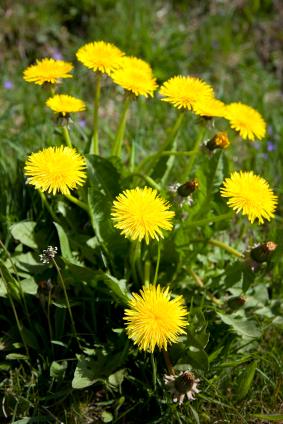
(138, 111), (185, 173)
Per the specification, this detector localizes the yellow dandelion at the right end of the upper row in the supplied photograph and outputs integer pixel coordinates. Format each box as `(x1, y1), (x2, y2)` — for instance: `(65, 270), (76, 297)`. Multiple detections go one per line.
(225, 103), (266, 141)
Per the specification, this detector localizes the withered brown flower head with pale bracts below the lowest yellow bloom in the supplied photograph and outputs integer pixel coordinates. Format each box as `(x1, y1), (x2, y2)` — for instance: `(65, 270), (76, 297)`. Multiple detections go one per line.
(164, 371), (199, 405)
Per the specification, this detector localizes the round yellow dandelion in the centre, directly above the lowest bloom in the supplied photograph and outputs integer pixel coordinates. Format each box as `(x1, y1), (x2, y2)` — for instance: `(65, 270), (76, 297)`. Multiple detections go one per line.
(111, 187), (175, 244)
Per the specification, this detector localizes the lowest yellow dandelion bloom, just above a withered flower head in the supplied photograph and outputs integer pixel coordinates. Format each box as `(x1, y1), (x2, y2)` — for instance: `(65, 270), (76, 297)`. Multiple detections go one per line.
(124, 285), (188, 352)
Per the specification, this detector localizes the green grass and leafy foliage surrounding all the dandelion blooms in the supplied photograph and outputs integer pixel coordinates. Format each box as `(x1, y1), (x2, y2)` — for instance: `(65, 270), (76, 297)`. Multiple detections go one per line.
(0, 0), (283, 424)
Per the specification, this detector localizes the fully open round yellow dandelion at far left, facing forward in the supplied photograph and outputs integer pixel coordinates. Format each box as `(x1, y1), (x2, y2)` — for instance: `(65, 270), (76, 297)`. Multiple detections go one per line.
(25, 146), (86, 194)
